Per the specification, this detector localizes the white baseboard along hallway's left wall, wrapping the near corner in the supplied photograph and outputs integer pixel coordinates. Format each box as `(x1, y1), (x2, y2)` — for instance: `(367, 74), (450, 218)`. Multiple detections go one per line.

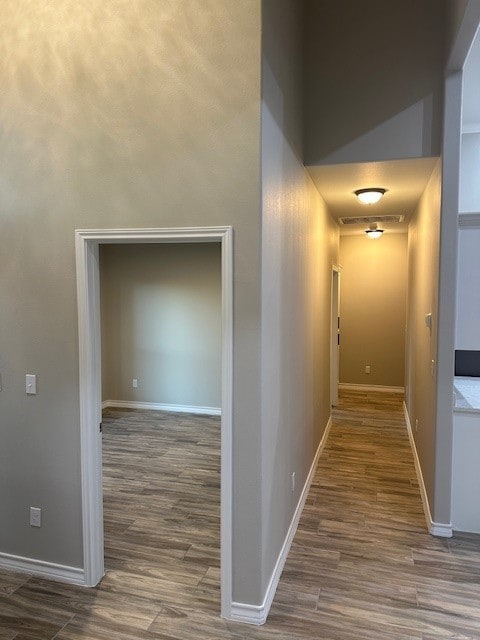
(230, 417), (332, 625)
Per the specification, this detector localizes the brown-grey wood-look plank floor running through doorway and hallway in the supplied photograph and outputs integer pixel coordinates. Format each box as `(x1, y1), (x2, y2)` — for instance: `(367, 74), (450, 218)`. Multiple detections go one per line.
(0, 393), (480, 640)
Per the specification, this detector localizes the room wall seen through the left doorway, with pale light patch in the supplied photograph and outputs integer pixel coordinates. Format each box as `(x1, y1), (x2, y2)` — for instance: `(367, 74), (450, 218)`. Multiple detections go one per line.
(100, 243), (222, 408)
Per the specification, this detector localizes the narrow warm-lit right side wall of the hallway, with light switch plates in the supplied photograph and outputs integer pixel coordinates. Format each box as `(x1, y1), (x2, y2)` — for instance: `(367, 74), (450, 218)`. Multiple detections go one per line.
(406, 161), (442, 508)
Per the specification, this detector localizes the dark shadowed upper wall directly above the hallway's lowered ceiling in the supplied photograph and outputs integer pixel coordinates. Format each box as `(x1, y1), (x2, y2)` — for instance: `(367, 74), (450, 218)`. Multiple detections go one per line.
(305, 0), (445, 165)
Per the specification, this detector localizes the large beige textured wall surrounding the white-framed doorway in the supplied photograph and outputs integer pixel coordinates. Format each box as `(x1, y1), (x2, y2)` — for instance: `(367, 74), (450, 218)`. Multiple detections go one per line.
(0, 0), (261, 601)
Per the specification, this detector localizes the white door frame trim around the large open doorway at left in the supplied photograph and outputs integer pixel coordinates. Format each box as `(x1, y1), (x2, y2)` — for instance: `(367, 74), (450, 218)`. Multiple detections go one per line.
(75, 227), (233, 618)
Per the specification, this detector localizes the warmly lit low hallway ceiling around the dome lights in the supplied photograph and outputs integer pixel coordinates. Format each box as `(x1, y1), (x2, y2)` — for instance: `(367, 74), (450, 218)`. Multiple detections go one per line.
(307, 158), (437, 235)
